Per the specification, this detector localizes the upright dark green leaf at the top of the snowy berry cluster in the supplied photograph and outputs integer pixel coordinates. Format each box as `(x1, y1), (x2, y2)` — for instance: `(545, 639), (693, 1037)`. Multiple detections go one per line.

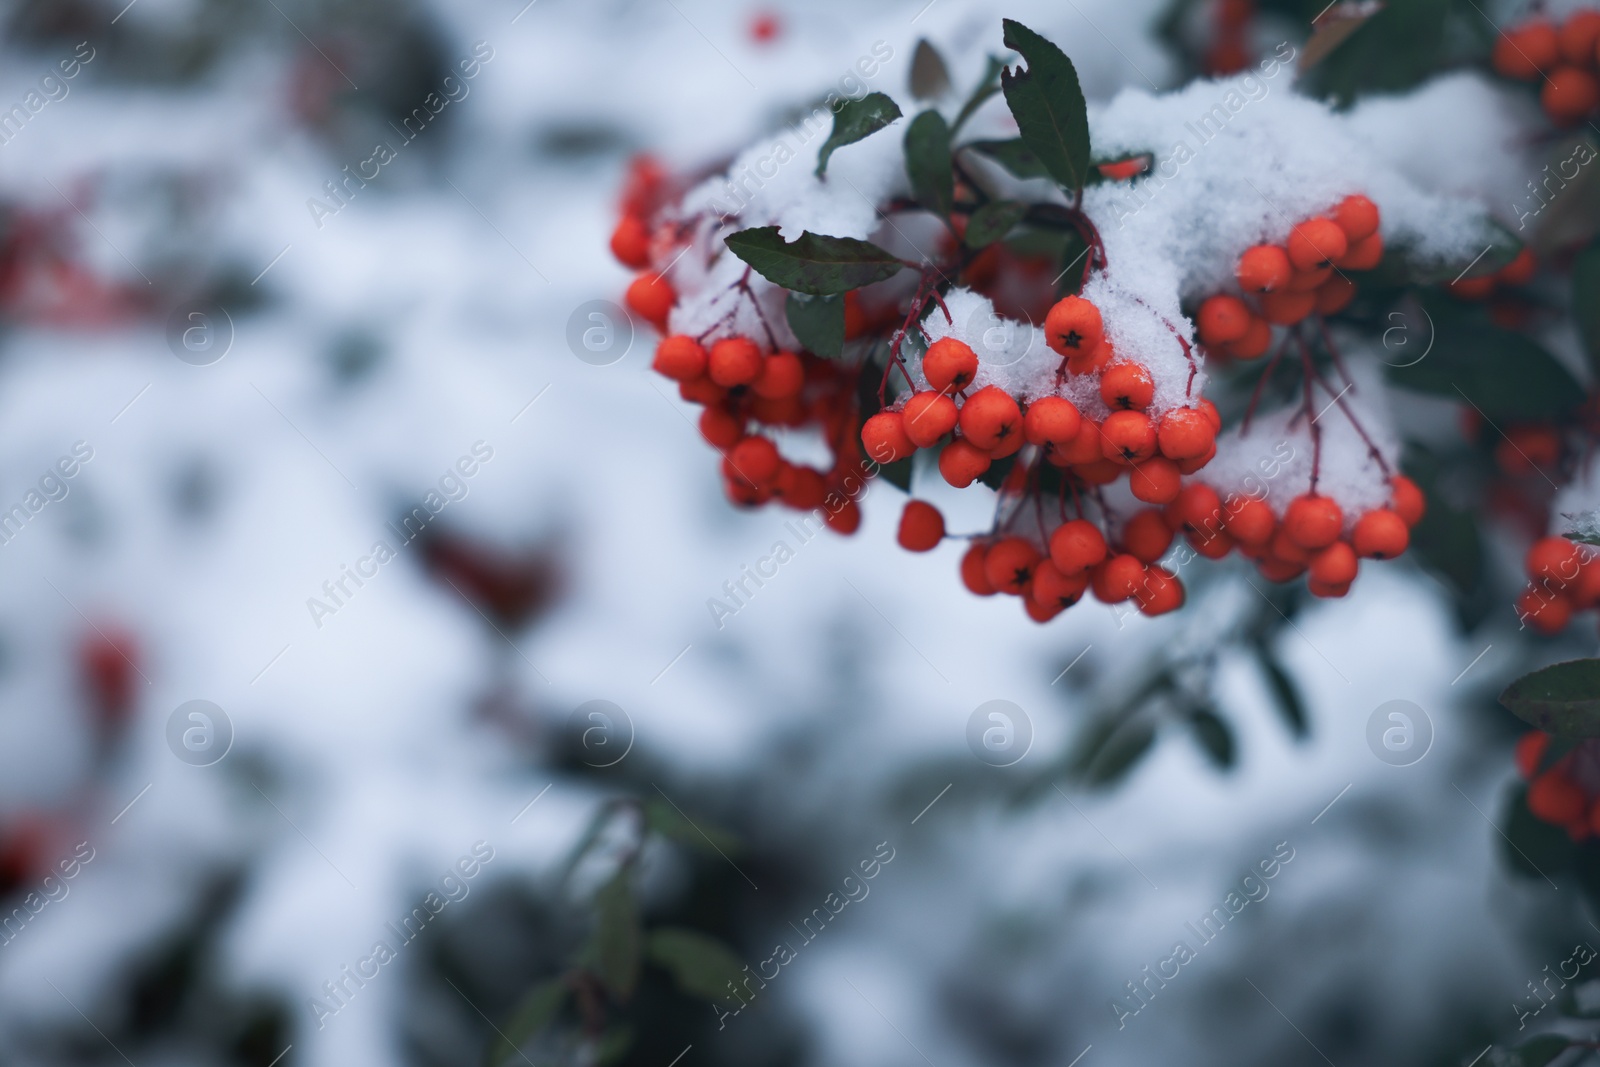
(1000, 19), (1090, 194)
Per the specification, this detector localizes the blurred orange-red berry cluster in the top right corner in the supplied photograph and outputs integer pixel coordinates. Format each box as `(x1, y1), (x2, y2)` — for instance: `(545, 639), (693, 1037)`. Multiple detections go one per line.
(1490, 8), (1600, 126)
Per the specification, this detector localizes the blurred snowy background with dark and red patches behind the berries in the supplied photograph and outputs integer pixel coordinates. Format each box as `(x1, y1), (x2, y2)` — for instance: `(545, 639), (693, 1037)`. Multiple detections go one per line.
(0, 0), (1574, 1067)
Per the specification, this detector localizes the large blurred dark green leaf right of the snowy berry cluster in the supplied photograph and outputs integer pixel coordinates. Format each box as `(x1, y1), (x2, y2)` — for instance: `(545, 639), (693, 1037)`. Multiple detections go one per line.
(1389, 293), (1584, 422)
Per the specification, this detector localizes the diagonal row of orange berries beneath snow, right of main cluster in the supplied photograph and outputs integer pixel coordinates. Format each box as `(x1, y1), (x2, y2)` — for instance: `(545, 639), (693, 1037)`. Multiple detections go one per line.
(1195, 195), (1384, 360)
